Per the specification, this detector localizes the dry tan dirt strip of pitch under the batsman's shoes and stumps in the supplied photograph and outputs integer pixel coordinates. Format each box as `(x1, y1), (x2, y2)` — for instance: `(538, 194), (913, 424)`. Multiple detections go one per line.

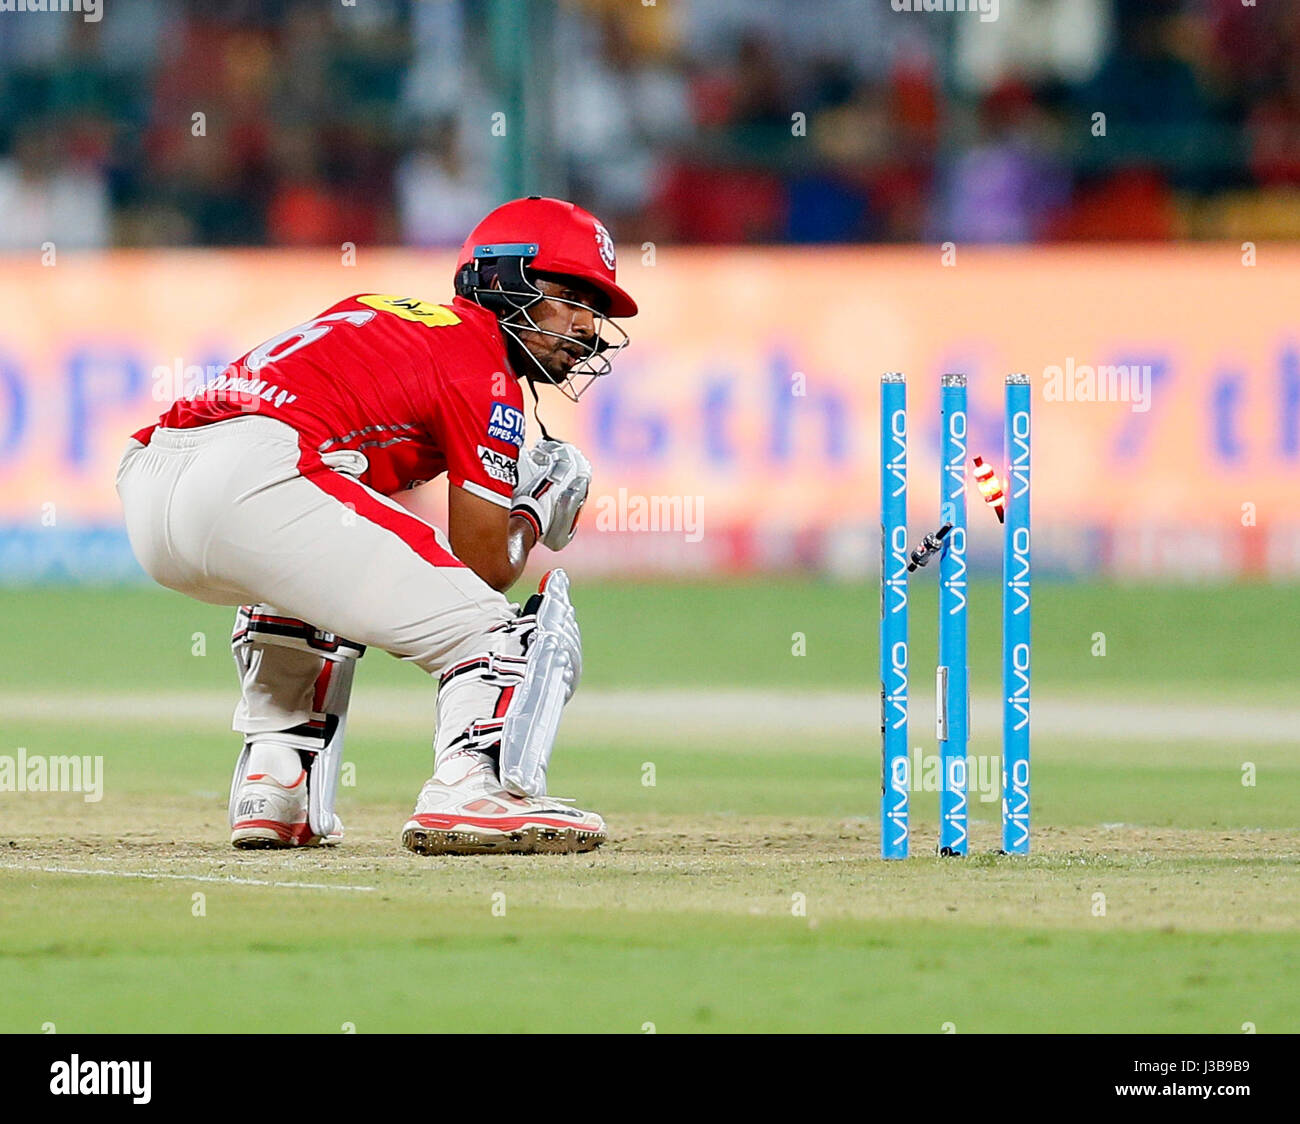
(0, 797), (1300, 932)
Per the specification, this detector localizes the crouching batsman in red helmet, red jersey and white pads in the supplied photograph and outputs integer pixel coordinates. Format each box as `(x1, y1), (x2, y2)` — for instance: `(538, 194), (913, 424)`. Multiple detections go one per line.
(117, 196), (637, 855)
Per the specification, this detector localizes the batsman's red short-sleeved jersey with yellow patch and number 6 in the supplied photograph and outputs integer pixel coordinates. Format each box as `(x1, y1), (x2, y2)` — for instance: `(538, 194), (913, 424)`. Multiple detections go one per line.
(135, 294), (524, 507)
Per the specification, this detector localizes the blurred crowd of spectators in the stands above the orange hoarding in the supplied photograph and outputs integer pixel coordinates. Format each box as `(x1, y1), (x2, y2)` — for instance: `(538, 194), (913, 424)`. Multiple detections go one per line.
(0, 0), (1300, 249)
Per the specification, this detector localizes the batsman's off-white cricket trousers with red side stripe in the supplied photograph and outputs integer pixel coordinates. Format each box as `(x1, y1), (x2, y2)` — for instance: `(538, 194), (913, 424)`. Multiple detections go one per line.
(117, 416), (515, 742)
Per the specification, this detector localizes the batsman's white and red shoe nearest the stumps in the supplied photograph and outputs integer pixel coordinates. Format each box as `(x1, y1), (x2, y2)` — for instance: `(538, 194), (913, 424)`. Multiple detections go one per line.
(402, 769), (606, 855)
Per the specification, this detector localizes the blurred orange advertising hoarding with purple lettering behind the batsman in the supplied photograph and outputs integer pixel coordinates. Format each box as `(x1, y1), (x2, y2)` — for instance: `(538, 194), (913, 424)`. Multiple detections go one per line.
(0, 246), (1300, 580)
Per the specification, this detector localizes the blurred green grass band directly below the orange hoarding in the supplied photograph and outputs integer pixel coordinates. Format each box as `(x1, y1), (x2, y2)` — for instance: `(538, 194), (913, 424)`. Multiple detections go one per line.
(0, 580), (1300, 702)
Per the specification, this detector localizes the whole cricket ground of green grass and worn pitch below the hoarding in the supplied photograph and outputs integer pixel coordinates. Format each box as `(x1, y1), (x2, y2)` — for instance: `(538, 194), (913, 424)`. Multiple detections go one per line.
(0, 581), (1300, 1033)
